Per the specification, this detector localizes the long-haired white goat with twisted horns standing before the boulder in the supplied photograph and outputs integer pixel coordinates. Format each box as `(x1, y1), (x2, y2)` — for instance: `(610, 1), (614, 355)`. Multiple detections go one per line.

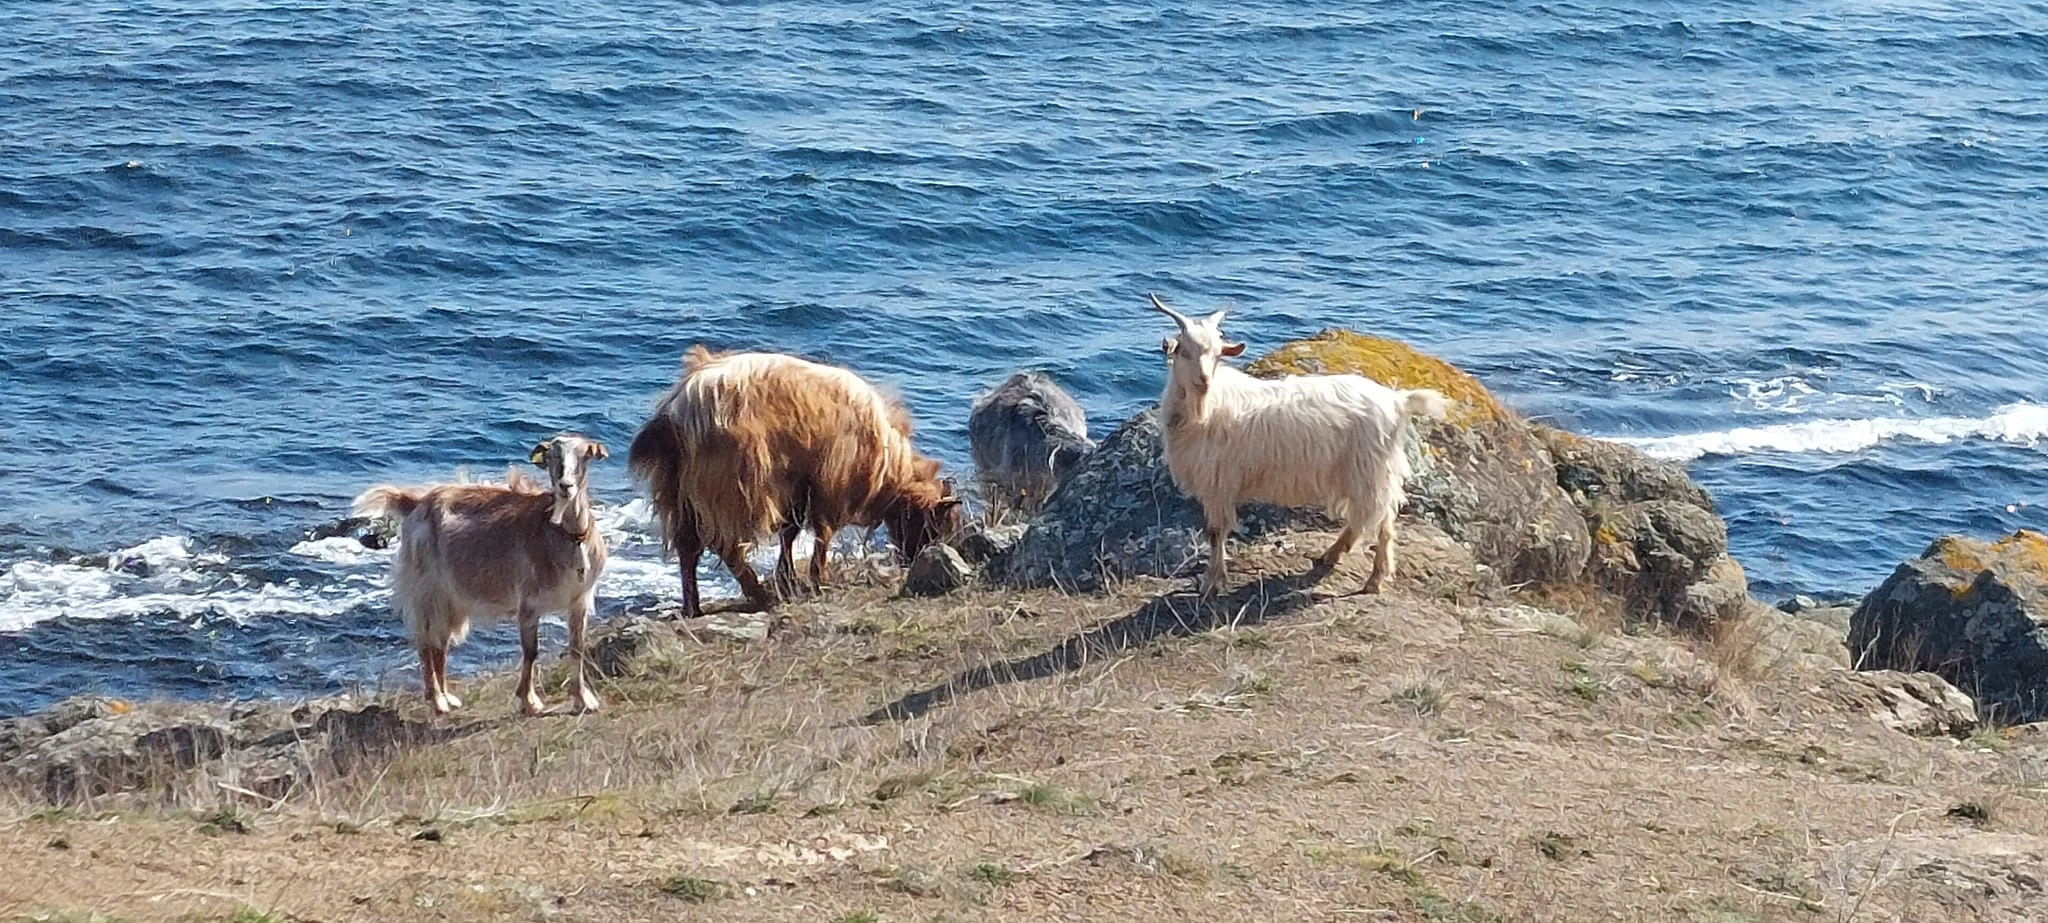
(1151, 295), (1448, 596)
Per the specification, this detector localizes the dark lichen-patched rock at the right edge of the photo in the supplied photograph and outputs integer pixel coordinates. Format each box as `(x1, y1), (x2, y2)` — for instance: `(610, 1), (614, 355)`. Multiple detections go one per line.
(1849, 530), (2048, 724)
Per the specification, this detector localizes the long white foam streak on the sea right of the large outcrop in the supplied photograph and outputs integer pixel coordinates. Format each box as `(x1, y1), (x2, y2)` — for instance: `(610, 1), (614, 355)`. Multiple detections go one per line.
(1616, 403), (2048, 460)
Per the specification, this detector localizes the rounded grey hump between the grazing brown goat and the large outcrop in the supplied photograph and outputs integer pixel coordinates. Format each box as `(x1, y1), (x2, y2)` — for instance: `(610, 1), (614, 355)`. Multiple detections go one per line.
(967, 372), (1096, 512)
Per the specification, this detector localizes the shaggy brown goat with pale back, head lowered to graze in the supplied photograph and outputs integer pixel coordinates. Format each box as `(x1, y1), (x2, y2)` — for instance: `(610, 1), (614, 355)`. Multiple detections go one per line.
(627, 346), (961, 618)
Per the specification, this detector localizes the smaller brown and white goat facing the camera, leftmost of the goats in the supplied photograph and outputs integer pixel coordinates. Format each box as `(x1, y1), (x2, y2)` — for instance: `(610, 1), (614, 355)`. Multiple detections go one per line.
(354, 436), (608, 714)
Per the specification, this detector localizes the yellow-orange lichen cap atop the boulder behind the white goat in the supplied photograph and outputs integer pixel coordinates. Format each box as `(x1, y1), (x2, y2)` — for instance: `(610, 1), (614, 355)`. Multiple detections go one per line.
(1245, 329), (1513, 426)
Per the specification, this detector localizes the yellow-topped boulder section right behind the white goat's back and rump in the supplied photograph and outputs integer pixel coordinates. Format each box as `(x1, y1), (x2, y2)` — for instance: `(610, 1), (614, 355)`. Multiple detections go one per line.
(1245, 329), (1587, 583)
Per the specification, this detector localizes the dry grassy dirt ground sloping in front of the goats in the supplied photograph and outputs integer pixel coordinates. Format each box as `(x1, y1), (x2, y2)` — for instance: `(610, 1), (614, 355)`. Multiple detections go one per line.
(0, 536), (2048, 923)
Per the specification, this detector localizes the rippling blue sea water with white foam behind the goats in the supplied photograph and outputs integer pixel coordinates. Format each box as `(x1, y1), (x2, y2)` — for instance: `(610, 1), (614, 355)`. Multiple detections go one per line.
(0, 0), (2048, 714)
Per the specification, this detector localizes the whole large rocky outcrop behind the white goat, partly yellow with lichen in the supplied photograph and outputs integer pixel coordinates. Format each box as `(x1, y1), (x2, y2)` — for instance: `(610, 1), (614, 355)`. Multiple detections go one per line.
(991, 329), (1751, 624)
